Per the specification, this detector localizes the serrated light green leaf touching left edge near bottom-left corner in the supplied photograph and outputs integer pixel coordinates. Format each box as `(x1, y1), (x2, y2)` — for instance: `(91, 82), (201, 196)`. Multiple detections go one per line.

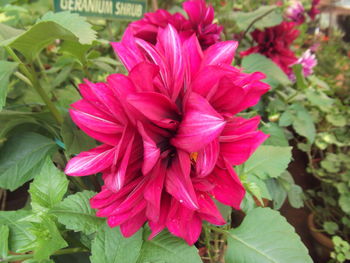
(0, 210), (35, 252)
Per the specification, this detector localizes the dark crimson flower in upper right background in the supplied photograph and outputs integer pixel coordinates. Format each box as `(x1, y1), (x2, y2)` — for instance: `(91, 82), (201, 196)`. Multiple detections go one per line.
(240, 21), (299, 75)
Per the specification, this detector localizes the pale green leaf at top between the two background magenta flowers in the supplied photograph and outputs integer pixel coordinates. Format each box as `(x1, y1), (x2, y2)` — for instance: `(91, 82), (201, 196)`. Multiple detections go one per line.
(230, 5), (283, 30)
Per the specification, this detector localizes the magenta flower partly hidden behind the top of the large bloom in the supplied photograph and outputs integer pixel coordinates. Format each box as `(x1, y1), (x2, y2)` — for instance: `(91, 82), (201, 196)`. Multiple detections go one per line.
(130, 0), (223, 49)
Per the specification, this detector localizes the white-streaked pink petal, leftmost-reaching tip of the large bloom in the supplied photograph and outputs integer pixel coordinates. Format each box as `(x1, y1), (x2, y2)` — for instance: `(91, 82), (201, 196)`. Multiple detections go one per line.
(65, 145), (114, 176)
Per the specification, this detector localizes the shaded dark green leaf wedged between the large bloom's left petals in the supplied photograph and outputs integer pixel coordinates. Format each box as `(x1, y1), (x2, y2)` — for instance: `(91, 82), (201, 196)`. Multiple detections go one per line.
(61, 115), (96, 155)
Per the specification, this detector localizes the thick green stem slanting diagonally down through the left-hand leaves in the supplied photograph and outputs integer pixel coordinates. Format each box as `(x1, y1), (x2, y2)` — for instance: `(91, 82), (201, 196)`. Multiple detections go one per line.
(5, 47), (63, 124)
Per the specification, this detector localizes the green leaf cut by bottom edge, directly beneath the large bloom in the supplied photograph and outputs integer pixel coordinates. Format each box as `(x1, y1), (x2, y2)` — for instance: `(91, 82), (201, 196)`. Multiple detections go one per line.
(137, 228), (202, 263)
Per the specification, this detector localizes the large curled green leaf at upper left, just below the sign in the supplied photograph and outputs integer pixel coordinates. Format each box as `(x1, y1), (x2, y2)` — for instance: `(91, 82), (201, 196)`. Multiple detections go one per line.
(0, 12), (96, 61)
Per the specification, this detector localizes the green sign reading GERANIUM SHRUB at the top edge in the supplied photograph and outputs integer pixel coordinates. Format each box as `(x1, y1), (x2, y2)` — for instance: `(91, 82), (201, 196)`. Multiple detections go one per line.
(54, 0), (146, 20)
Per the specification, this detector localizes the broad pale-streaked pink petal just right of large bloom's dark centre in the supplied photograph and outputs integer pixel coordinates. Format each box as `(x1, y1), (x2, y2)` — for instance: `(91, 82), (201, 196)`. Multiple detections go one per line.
(170, 92), (226, 152)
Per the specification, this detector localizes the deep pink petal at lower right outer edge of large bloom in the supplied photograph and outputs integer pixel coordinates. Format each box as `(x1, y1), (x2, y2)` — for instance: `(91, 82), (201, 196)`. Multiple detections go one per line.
(209, 164), (245, 210)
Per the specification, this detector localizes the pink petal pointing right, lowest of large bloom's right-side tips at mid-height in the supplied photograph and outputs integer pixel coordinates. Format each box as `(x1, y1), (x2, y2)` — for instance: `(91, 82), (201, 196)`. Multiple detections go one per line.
(220, 131), (269, 165)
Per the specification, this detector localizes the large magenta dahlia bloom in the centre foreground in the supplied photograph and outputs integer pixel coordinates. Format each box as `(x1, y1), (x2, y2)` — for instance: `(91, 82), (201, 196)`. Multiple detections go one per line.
(65, 25), (269, 245)
